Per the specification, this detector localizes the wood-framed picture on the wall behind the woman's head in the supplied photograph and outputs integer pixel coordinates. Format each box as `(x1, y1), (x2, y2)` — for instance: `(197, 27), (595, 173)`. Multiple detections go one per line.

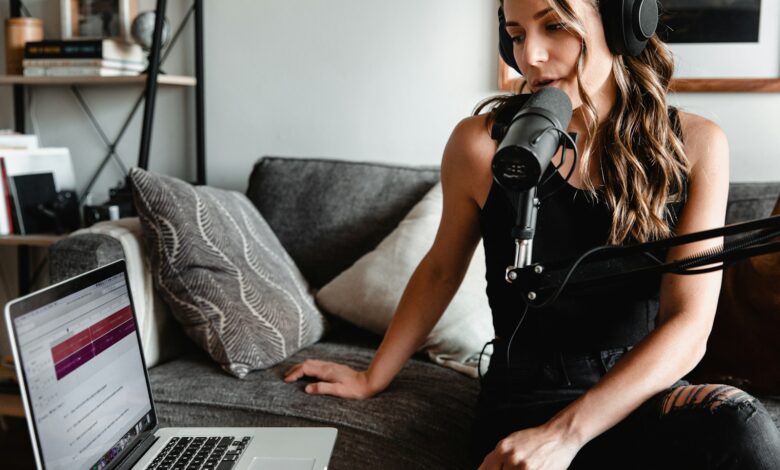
(498, 0), (780, 92)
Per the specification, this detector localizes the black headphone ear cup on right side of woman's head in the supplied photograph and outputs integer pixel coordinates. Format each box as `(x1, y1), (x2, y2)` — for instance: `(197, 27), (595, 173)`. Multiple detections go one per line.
(599, 0), (658, 56)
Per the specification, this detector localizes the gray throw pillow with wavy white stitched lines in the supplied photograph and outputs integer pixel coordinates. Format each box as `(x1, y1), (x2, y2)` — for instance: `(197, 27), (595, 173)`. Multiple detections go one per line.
(130, 169), (325, 378)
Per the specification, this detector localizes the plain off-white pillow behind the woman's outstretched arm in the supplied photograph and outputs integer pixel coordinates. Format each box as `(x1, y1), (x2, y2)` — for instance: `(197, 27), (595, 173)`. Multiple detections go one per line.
(316, 183), (493, 377)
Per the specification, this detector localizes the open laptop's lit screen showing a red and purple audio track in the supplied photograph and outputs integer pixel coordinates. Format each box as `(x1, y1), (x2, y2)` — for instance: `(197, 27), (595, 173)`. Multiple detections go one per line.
(13, 269), (155, 469)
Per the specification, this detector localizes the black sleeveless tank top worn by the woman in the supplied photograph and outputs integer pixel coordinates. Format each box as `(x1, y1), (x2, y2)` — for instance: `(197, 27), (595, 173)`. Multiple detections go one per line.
(479, 99), (685, 356)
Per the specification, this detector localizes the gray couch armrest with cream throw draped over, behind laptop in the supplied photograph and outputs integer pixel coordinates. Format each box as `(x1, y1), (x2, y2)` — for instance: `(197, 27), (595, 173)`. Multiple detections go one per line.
(49, 217), (186, 368)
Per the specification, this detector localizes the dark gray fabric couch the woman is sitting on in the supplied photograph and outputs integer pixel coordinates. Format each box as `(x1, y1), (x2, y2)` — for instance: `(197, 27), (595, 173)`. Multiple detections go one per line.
(50, 158), (780, 470)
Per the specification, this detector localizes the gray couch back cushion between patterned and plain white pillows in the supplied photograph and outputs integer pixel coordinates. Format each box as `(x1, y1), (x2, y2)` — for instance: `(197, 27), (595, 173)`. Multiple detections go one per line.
(247, 157), (439, 288)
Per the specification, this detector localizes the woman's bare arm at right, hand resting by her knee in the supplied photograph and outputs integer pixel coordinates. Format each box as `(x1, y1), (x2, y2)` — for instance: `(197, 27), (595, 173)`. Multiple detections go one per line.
(485, 115), (729, 468)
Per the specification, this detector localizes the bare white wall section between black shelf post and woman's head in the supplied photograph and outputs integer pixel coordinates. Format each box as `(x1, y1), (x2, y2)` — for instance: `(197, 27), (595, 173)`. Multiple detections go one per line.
(201, 0), (497, 188)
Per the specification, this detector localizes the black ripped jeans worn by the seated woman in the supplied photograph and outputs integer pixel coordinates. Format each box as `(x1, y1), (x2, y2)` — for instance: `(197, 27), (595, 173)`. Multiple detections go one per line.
(472, 348), (780, 470)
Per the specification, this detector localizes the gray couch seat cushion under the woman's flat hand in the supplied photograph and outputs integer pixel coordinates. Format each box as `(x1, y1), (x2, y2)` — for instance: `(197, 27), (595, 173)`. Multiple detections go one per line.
(149, 336), (478, 470)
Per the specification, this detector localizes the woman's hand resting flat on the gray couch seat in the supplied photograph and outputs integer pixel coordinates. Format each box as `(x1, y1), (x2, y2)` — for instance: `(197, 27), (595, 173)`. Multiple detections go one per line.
(284, 359), (380, 400)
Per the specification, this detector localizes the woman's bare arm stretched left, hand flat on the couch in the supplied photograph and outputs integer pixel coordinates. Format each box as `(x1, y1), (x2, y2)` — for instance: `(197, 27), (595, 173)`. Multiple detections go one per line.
(285, 117), (495, 399)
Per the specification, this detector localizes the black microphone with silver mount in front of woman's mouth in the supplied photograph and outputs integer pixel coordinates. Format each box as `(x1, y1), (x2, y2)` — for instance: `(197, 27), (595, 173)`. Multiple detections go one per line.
(492, 88), (572, 282)
